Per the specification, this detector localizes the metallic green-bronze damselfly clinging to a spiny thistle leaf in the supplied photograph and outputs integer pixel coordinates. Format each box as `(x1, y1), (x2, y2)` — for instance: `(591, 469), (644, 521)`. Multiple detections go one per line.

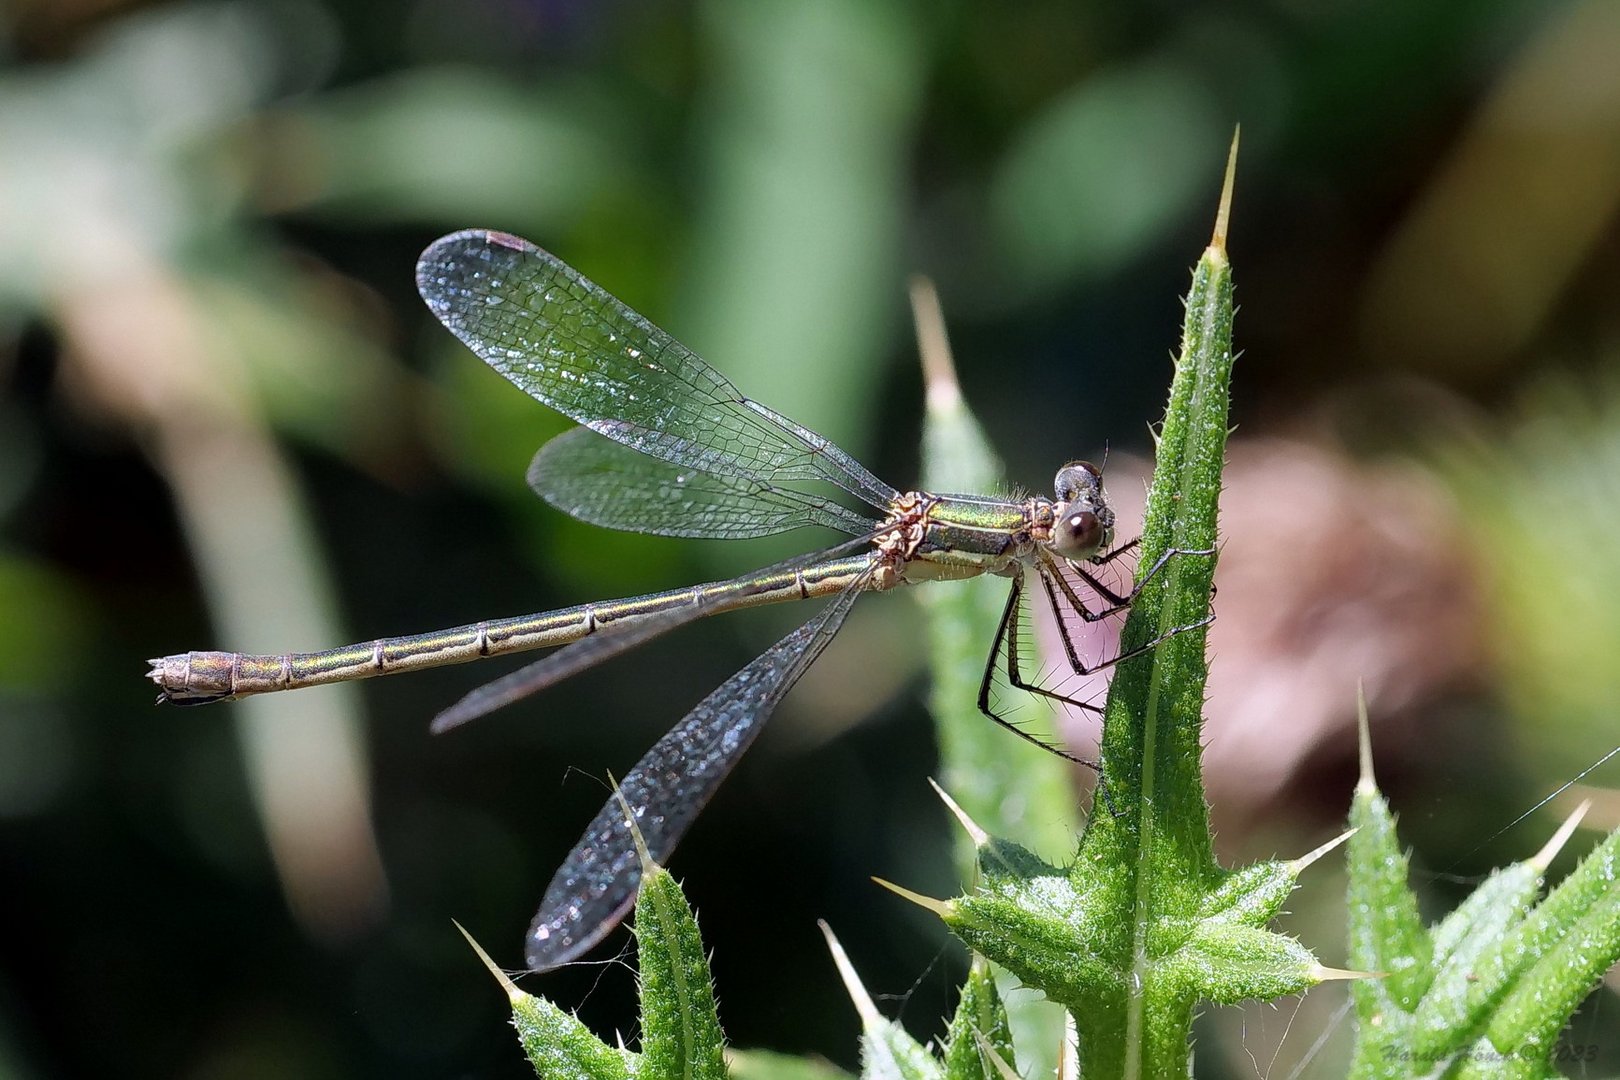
(149, 230), (1205, 970)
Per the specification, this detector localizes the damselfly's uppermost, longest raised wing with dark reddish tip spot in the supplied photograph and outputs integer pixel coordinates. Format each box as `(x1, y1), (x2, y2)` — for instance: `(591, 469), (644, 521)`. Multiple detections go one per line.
(416, 230), (897, 508)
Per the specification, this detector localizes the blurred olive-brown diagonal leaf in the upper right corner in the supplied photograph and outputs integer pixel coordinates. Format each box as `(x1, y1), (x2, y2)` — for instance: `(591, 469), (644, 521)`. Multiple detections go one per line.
(1356, 2), (1620, 379)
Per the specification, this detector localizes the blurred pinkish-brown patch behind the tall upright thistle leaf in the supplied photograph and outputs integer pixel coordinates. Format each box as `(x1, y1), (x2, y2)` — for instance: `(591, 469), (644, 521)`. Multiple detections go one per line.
(1047, 439), (1486, 844)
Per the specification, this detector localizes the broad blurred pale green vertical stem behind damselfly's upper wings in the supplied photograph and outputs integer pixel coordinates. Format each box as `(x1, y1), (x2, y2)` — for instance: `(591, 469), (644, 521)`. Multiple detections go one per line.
(679, 0), (922, 452)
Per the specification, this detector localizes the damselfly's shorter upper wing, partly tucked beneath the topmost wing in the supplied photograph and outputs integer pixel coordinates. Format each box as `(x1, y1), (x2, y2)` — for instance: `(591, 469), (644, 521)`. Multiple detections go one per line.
(528, 427), (876, 539)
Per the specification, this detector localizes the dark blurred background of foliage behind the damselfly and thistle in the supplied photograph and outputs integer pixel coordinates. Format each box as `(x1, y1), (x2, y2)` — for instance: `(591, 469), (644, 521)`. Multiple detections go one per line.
(0, 0), (1620, 1078)
